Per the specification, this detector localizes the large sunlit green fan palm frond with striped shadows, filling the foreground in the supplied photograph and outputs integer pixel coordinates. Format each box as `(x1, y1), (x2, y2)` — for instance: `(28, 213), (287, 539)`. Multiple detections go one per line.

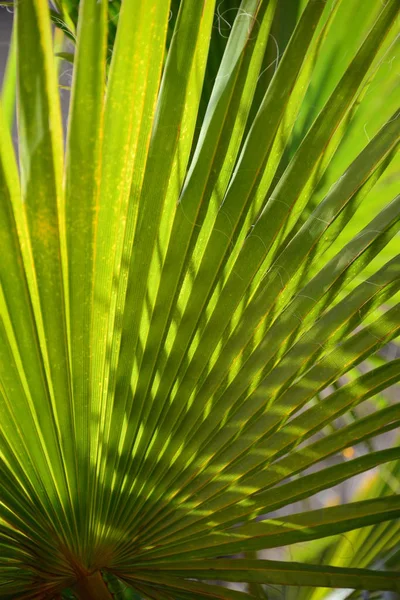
(0, 0), (400, 600)
